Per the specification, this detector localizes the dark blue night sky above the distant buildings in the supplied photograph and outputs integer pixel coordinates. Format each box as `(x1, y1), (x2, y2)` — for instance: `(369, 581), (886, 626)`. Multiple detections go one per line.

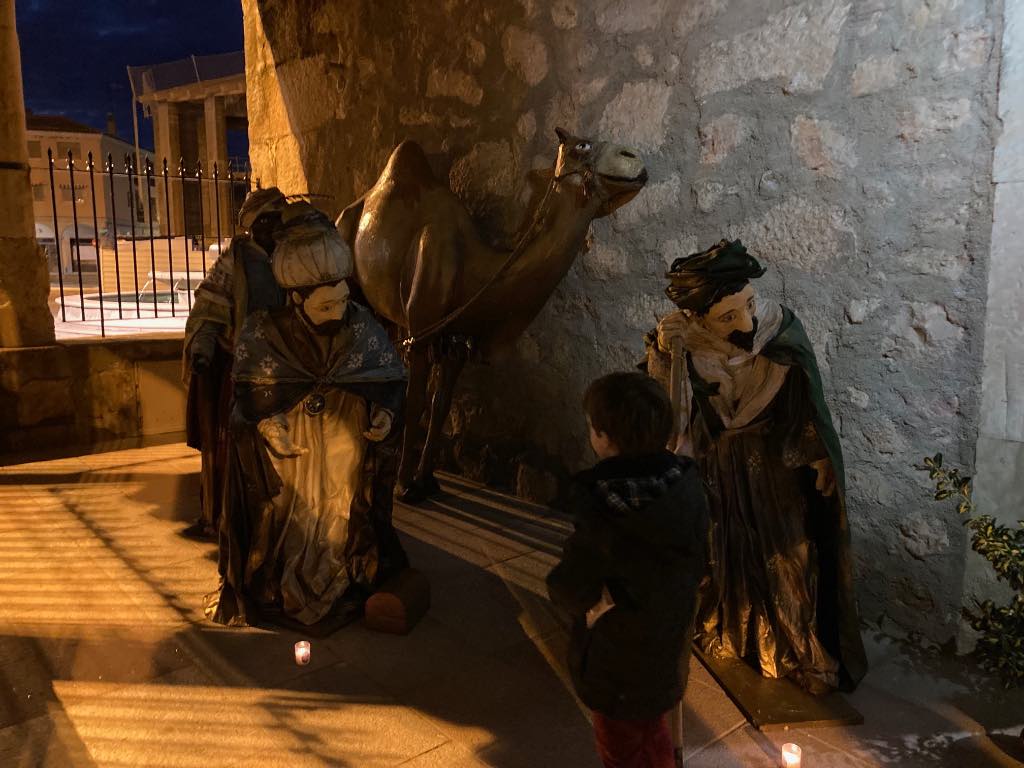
(14, 0), (247, 155)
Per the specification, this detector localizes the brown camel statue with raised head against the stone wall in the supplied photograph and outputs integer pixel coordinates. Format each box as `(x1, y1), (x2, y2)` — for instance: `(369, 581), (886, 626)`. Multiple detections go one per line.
(336, 129), (647, 504)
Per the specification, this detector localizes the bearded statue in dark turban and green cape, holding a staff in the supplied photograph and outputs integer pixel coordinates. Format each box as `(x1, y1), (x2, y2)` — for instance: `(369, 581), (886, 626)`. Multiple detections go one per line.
(647, 240), (866, 693)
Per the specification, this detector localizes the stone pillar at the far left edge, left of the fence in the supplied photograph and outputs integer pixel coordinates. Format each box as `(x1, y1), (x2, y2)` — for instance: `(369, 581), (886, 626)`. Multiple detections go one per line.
(0, 0), (53, 347)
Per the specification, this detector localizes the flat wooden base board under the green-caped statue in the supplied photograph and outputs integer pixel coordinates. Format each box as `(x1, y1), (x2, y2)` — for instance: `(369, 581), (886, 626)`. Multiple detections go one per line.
(693, 646), (864, 731)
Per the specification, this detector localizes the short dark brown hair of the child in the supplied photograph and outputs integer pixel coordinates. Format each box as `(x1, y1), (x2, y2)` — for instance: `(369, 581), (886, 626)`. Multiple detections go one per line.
(583, 372), (673, 456)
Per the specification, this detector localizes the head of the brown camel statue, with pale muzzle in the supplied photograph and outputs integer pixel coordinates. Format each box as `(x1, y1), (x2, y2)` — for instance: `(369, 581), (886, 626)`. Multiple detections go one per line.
(555, 128), (647, 218)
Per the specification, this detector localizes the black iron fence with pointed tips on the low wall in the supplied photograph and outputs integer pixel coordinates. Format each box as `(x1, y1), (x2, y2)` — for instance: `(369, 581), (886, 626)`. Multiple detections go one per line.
(45, 150), (259, 336)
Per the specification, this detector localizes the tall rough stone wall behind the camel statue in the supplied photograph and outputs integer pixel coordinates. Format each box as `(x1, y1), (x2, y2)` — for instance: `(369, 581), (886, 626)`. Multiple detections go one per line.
(243, 0), (1001, 640)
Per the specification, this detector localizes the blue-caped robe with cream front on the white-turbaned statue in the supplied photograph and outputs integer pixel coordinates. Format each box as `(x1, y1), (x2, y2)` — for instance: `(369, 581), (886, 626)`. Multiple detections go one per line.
(207, 302), (408, 625)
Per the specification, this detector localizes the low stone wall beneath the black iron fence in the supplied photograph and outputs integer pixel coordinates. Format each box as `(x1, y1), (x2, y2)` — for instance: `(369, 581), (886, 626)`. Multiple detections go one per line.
(0, 338), (185, 456)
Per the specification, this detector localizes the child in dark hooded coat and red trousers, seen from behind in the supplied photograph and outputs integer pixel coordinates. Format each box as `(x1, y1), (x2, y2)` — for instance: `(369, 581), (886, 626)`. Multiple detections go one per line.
(548, 373), (708, 768)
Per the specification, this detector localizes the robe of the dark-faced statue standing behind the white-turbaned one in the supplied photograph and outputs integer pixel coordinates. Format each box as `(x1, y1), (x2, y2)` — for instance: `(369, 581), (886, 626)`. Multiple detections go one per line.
(182, 234), (285, 532)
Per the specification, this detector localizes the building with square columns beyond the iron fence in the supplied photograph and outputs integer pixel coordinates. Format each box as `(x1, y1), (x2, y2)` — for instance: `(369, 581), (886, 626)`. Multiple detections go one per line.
(128, 51), (248, 237)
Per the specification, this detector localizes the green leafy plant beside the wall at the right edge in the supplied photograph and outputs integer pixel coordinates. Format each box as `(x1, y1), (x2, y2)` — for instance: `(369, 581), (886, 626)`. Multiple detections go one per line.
(918, 454), (1024, 688)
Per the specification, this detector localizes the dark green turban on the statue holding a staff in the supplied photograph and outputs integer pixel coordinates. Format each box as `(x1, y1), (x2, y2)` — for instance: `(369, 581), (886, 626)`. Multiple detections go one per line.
(665, 240), (765, 313)
